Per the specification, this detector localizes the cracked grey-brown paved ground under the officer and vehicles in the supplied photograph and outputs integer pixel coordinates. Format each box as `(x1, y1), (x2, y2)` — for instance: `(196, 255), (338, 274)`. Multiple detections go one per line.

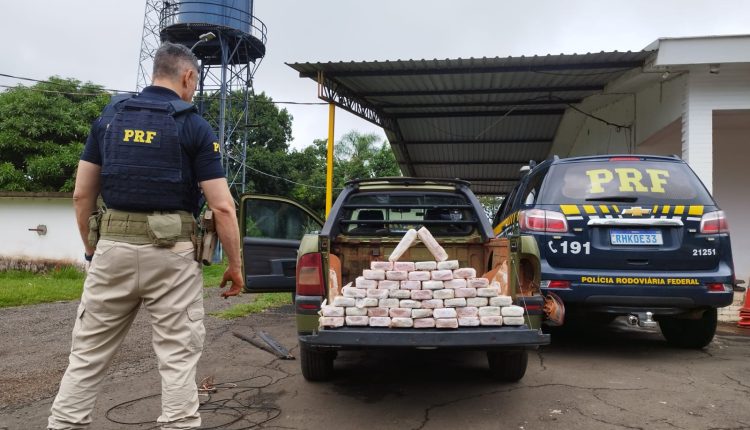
(0, 291), (750, 430)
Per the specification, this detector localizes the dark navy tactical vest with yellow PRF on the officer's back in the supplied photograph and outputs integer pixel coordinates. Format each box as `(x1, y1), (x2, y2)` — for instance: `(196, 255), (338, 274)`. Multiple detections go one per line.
(101, 97), (197, 212)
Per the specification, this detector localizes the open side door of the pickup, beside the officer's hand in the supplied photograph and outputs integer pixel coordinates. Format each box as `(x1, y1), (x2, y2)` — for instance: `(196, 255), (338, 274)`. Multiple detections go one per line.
(240, 194), (323, 293)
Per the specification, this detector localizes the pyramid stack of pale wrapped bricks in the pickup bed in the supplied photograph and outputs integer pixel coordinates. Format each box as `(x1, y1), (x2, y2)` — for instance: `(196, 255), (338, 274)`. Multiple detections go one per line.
(320, 228), (524, 329)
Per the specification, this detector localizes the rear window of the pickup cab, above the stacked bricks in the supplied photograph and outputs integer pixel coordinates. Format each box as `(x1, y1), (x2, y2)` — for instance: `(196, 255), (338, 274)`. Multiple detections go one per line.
(340, 192), (478, 236)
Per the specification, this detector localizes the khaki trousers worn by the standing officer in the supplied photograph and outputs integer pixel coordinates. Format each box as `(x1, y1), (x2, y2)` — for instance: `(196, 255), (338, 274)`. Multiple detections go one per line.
(48, 240), (206, 429)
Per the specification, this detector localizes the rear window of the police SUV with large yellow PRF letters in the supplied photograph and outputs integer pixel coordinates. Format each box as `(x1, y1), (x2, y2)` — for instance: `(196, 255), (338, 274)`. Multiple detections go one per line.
(537, 160), (713, 205)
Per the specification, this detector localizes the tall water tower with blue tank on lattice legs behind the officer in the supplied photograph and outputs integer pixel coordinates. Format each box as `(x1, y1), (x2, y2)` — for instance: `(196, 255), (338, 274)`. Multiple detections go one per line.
(137, 0), (266, 192)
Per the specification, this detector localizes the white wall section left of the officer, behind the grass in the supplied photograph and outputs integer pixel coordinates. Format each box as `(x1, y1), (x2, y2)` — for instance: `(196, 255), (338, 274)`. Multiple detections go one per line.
(0, 197), (84, 261)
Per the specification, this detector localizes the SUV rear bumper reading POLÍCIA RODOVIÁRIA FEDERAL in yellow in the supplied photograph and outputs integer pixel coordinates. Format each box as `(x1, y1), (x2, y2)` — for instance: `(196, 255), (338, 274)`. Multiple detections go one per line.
(542, 263), (734, 315)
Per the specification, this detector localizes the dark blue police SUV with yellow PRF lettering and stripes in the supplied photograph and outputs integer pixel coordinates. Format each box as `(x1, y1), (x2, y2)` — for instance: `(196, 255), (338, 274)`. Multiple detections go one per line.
(493, 155), (734, 348)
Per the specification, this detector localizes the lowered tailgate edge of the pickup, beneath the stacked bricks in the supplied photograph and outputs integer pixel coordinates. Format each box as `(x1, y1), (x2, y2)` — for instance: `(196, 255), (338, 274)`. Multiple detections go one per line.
(299, 326), (550, 349)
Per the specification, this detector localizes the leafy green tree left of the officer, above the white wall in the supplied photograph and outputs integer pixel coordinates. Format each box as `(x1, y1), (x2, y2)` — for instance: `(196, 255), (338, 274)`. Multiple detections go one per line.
(0, 77), (110, 192)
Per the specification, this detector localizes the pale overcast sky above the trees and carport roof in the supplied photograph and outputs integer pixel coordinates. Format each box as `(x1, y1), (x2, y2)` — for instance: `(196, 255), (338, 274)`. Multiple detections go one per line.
(0, 0), (750, 148)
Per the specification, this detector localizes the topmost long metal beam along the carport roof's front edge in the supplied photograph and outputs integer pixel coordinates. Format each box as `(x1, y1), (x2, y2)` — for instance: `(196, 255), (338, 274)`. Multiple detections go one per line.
(300, 60), (643, 78)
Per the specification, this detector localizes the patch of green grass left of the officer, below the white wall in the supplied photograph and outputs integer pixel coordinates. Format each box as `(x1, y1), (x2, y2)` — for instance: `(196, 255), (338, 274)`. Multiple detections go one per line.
(0, 267), (83, 308)
